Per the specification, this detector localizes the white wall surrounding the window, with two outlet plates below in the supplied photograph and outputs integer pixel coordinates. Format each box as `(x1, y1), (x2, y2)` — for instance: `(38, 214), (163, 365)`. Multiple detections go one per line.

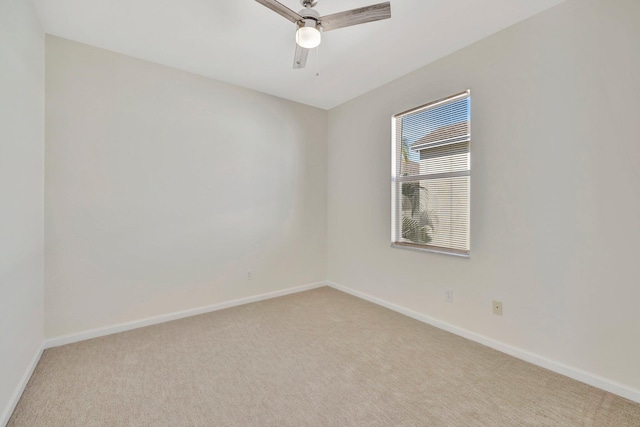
(328, 0), (640, 396)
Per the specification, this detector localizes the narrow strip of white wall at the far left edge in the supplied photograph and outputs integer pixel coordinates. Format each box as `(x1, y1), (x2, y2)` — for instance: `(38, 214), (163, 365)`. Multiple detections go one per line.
(0, 0), (44, 425)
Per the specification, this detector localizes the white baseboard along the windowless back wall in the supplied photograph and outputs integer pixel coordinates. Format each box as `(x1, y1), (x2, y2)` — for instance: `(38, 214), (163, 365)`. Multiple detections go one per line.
(44, 282), (327, 349)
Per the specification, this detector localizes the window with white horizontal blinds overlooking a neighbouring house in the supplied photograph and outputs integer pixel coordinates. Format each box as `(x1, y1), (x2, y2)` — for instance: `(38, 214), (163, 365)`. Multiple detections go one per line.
(391, 91), (471, 256)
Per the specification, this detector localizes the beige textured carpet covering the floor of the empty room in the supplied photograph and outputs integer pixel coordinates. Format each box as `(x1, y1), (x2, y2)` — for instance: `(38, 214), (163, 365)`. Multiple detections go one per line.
(9, 288), (640, 427)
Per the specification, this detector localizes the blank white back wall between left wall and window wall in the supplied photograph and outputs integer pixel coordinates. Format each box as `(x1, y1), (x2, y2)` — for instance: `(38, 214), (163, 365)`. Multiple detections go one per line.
(45, 36), (327, 337)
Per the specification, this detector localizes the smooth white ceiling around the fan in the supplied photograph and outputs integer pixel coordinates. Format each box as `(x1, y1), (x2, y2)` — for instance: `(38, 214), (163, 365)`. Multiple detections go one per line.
(33, 0), (564, 109)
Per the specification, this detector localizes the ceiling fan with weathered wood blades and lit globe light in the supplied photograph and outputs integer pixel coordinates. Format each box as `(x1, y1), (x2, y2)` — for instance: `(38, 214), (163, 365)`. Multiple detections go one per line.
(256, 0), (391, 68)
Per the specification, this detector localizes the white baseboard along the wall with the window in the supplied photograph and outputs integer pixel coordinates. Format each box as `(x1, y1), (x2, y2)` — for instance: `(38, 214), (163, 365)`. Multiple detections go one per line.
(327, 282), (640, 403)
